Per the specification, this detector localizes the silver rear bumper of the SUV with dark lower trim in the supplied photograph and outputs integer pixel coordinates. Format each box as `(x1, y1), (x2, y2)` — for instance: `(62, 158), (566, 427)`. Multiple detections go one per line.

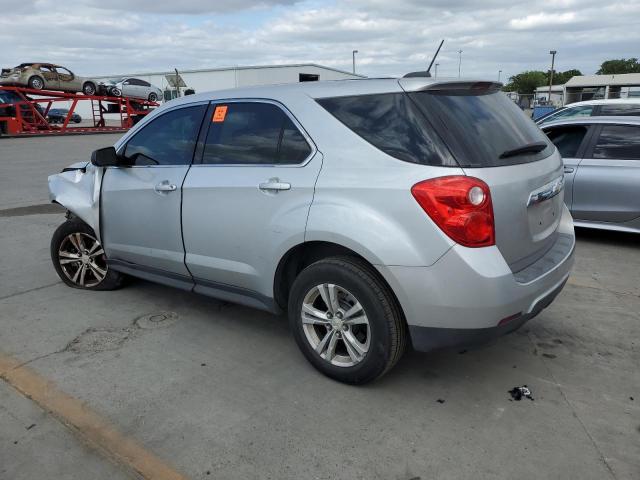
(378, 203), (575, 351)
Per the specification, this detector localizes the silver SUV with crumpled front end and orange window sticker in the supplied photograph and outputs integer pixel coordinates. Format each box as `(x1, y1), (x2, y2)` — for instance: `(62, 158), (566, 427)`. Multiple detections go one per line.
(49, 78), (575, 384)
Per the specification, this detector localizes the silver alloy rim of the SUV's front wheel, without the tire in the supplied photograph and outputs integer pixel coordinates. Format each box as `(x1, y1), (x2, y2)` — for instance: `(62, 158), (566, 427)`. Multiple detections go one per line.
(58, 232), (108, 288)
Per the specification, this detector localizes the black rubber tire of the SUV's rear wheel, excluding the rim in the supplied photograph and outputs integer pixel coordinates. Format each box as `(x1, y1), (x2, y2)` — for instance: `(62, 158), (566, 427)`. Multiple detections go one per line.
(288, 257), (407, 385)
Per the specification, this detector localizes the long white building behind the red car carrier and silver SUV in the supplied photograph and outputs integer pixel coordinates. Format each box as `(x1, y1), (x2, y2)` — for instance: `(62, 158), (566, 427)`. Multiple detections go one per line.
(72, 63), (365, 119)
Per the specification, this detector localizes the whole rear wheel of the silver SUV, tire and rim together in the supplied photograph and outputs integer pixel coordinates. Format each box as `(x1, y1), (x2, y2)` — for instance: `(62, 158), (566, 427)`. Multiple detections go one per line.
(288, 257), (407, 385)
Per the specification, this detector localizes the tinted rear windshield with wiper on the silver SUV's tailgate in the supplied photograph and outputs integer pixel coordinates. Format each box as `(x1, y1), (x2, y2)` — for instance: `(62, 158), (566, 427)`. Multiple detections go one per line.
(408, 90), (554, 168)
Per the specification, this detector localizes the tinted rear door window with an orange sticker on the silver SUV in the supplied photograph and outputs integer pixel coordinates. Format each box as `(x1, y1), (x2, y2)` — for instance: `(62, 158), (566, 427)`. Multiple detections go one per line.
(202, 102), (311, 165)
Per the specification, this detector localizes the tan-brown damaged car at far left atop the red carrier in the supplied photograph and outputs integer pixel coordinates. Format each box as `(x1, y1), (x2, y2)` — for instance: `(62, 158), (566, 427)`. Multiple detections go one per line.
(0, 63), (98, 95)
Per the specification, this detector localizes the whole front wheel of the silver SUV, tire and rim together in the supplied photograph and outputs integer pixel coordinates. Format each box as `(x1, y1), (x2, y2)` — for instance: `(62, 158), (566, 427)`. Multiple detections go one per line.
(51, 218), (124, 290)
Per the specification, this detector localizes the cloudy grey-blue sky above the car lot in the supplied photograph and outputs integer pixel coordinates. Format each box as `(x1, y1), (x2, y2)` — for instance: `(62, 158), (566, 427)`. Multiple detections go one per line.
(0, 0), (640, 81)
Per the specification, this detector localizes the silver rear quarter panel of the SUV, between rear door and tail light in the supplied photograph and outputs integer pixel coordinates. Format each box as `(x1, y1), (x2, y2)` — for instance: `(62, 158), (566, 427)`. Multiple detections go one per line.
(293, 95), (463, 266)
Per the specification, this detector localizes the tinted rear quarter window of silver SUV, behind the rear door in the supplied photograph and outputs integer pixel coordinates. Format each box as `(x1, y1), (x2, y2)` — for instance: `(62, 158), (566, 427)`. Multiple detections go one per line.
(318, 93), (457, 166)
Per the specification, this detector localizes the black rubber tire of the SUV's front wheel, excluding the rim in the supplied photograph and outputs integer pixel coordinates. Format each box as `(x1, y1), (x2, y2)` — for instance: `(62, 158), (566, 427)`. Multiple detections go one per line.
(50, 217), (124, 290)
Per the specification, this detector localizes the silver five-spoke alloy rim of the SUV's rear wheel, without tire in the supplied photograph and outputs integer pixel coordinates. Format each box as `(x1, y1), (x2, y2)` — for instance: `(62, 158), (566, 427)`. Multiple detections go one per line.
(301, 283), (371, 367)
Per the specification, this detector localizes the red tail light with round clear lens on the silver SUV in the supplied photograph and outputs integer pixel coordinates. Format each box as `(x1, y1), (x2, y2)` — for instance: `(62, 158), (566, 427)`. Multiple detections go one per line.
(411, 176), (496, 247)
